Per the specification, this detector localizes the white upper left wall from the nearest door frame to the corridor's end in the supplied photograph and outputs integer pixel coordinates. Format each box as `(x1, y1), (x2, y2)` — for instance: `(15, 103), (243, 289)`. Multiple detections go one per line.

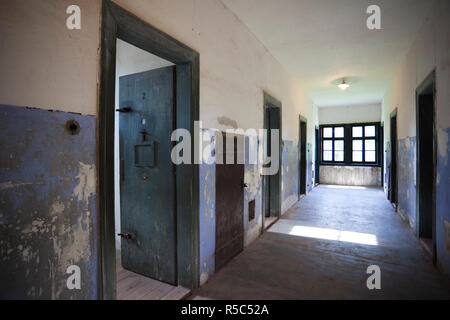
(114, 0), (313, 142)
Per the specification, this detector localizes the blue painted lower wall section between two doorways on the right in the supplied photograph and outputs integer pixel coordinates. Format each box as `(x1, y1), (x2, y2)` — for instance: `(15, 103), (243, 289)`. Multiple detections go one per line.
(398, 137), (416, 228)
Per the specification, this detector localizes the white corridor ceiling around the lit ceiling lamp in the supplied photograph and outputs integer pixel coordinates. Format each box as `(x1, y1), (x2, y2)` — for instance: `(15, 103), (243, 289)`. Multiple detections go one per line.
(222, 0), (433, 106)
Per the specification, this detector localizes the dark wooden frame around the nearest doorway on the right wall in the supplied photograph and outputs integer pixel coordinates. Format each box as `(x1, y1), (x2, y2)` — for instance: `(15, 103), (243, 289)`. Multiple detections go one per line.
(415, 70), (437, 265)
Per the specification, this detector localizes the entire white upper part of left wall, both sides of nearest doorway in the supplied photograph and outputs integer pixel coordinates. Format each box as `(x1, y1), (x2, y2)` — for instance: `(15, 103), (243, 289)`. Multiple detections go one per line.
(0, 0), (314, 143)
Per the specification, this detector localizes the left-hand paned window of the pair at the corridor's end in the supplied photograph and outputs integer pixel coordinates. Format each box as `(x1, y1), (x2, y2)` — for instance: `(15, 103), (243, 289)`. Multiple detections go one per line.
(322, 127), (344, 162)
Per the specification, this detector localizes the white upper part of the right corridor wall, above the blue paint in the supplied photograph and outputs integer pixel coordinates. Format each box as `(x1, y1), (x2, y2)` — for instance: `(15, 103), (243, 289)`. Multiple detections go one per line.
(382, 0), (450, 141)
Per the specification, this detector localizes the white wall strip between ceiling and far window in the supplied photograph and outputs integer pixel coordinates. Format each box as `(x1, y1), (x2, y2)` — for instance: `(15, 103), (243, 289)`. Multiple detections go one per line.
(319, 103), (381, 124)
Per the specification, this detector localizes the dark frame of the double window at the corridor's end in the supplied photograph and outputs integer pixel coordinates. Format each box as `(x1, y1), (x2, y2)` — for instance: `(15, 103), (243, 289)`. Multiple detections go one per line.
(318, 122), (382, 167)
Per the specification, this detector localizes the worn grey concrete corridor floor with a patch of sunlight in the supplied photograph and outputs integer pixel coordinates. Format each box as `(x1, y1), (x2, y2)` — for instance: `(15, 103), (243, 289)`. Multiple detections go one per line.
(192, 185), (450, 300)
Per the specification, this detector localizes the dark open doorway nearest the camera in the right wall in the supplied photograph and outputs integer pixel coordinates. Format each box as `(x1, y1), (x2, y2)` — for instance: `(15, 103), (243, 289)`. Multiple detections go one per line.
(416, 72), (436, 263)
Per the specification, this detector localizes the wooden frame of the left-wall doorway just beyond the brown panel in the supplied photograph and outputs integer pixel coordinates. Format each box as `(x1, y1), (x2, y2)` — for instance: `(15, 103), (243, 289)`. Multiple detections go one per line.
(262, 92), (283, 231)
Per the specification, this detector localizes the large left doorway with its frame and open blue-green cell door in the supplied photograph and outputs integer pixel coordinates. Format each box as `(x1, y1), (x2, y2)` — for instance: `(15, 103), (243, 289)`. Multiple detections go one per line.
(99, 0), (199, 299)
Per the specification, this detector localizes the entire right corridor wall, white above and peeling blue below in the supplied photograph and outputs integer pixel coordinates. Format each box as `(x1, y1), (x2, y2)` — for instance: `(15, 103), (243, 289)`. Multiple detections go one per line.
(382, 0), (450, 275)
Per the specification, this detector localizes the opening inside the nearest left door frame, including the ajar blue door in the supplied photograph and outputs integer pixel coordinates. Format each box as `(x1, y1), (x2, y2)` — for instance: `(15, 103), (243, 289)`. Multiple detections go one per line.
(114, 39), (186, 300)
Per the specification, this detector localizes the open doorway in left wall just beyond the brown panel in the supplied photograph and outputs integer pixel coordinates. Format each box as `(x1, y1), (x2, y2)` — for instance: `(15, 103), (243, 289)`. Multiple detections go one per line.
(263, 93), (282, 229)
